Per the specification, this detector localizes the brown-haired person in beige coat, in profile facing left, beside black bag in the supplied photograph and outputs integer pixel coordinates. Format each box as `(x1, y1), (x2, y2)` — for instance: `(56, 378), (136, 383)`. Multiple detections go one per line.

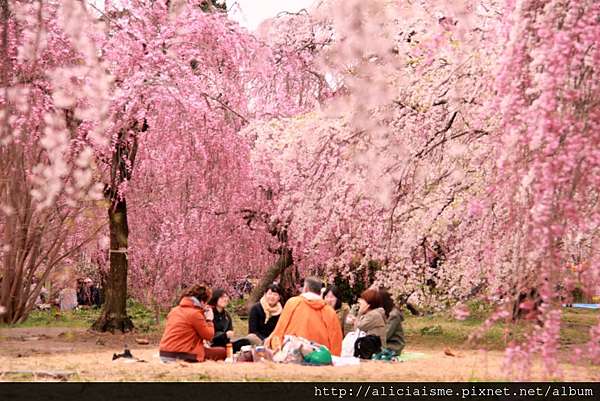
(349, 288), (386, 347)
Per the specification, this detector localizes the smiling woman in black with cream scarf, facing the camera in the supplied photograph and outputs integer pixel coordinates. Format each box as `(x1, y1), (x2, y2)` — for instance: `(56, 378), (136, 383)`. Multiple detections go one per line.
(248, 284), (283, 343)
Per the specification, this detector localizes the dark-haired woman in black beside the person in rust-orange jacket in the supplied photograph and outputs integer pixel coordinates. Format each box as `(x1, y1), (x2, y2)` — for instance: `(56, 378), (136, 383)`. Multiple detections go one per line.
(208, 288), (262, 352)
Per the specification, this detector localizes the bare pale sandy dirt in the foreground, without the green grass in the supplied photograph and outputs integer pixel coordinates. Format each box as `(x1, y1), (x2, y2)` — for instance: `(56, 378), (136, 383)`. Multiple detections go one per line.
(0, 328), (600, 381)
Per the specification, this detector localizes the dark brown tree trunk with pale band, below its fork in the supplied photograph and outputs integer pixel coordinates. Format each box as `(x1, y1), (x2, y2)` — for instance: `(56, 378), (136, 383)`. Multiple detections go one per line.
(92, 199), (133, 333)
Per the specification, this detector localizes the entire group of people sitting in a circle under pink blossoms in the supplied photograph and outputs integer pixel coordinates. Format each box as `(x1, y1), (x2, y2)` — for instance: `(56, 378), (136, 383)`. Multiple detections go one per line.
(159, 277), (405, 362)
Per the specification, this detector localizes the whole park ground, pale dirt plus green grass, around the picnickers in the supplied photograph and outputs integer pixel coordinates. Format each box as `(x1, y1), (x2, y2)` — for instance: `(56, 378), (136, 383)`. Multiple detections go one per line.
(0, 302), (600, 381)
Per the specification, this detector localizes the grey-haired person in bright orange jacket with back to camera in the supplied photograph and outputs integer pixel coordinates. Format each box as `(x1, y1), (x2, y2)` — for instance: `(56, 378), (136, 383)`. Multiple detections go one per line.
(265, 277), (342, 356)
